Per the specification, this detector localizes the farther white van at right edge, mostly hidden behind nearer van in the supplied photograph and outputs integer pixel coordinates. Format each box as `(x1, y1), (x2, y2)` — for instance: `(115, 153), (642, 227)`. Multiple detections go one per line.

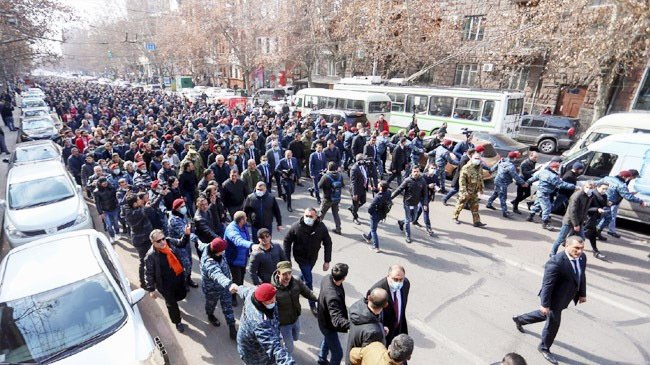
(562, 112), (650, 157)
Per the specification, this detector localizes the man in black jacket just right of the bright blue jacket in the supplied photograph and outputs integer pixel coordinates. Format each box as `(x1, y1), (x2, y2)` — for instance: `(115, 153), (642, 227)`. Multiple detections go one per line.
(243, 181), (282, 237)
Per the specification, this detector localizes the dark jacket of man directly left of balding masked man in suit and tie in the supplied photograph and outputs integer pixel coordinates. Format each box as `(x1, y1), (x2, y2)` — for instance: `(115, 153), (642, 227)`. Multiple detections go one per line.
(344, 299), (386, 364)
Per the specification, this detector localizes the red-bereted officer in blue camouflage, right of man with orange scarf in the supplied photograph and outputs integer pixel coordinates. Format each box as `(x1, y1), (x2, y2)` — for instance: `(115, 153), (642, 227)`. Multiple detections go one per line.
(200, 237), (237, 340)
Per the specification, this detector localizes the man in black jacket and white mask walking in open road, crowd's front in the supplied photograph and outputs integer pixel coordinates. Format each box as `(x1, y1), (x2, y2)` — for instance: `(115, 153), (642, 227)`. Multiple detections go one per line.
(284, 207), (332, 314)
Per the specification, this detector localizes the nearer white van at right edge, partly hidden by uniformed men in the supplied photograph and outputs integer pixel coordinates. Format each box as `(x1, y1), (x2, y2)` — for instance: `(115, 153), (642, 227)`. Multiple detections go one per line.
(560, 133), (650, 224)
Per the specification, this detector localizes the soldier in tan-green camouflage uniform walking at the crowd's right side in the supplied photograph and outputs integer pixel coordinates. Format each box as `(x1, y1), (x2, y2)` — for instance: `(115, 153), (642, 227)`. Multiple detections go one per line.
(452, 153), (485, 227)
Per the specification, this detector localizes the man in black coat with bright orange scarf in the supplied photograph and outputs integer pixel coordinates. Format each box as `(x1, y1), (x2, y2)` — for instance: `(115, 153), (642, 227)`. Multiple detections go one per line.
(144, 226), (190, 332)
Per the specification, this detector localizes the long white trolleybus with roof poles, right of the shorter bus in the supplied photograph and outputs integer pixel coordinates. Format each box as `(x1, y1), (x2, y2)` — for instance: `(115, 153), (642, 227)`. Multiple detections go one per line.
(334, 83), (524, 135)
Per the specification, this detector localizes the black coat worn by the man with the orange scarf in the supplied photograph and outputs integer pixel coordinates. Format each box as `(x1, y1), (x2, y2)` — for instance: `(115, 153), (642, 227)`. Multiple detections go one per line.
(144, 235), (190, 292)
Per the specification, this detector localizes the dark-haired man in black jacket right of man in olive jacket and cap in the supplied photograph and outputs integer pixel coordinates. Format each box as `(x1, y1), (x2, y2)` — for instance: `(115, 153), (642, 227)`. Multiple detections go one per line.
(317, 263), (350, 365)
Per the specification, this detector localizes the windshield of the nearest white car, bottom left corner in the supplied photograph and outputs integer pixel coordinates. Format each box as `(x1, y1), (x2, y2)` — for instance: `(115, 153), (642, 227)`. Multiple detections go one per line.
(0, 273), (126, 364)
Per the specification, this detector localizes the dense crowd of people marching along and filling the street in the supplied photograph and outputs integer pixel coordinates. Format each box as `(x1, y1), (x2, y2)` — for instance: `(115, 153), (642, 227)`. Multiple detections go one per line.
(3, 79), (645, 364)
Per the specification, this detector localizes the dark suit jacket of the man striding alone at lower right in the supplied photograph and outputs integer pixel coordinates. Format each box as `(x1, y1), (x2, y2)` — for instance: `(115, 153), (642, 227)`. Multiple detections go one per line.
(539, 250), (587, 310)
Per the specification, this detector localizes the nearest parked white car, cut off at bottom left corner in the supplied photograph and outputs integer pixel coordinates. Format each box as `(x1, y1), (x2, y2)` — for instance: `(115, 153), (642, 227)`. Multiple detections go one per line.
(0, 230), (163, 365)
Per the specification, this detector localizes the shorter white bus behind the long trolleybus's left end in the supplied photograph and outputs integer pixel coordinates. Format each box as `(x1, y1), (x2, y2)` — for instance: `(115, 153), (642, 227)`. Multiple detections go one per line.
(293, 88), (391, 126)
